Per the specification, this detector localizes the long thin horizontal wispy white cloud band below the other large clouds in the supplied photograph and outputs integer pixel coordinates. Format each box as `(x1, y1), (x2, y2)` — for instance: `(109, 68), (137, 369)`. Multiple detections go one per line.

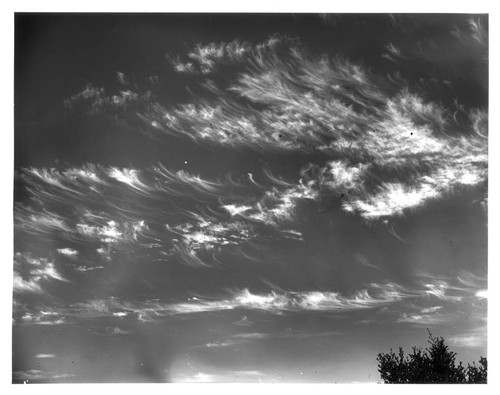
(13, 283), (415, 324)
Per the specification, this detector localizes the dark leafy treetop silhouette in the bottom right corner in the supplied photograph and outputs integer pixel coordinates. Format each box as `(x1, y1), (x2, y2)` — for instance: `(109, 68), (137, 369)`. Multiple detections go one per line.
(377, 330), (487, 384)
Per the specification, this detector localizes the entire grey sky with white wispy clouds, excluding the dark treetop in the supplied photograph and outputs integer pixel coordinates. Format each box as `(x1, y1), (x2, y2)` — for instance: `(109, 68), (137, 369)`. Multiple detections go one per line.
(12, 14), (488, 383)
